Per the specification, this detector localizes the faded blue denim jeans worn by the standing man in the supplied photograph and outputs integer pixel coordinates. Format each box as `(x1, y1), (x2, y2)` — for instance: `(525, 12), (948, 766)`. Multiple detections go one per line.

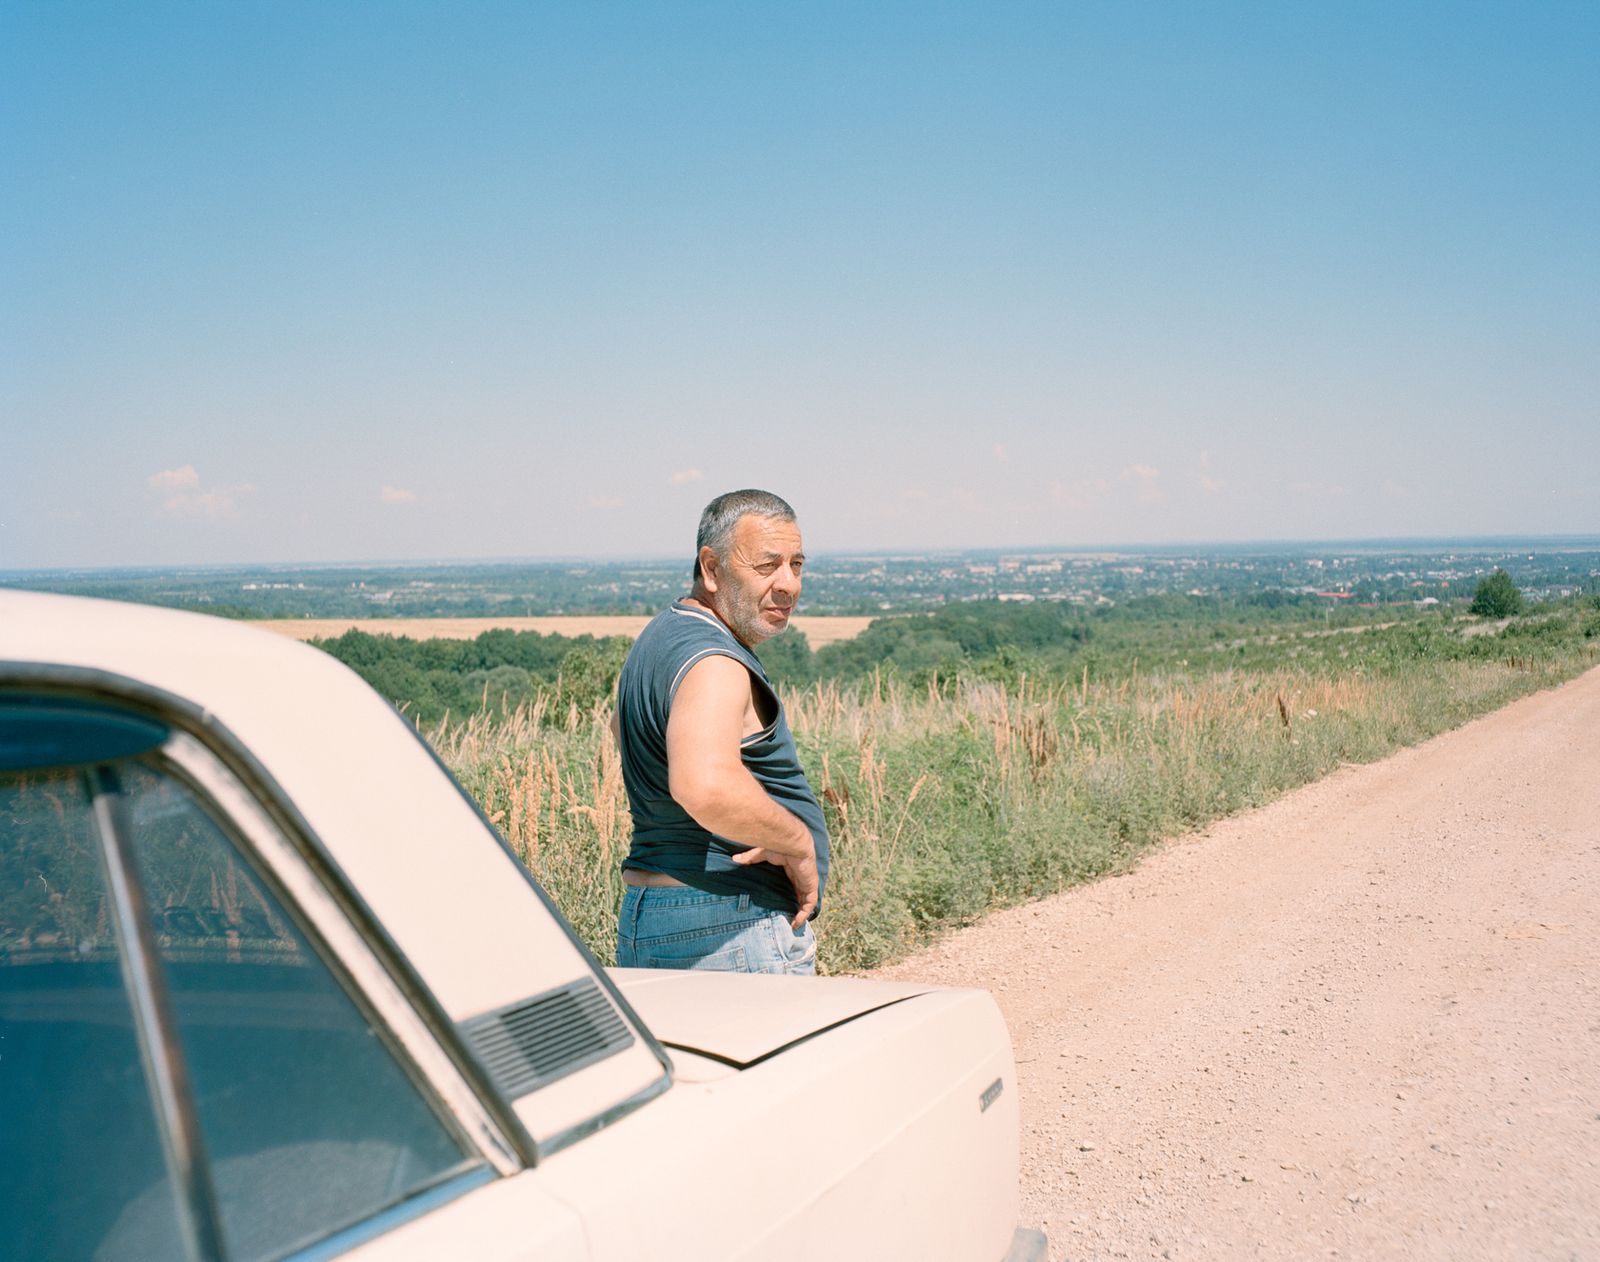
(616, 885), (816, 976)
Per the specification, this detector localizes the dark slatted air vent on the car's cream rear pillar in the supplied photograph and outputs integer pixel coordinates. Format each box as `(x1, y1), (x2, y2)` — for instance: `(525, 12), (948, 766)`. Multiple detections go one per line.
(461, 977), (634, 1100)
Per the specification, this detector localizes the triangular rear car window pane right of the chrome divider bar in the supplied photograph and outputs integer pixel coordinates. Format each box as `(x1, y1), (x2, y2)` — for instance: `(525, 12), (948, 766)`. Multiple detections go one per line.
(107, 766), (475, 1259)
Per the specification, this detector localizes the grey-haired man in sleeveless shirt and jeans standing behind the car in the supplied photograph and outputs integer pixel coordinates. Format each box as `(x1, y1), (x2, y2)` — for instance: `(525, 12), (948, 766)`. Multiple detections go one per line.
(611, 491), (827, 974)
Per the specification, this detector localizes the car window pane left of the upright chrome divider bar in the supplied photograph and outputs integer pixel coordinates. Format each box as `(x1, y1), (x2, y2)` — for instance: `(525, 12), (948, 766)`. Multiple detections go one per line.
(0, 773), (184, 1262)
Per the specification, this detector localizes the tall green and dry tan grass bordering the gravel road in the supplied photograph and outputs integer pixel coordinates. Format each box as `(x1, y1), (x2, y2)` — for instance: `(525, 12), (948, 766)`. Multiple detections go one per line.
(429, 614), (1600, 972)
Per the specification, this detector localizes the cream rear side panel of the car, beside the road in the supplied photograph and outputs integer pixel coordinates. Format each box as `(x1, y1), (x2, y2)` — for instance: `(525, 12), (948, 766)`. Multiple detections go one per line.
(542, 977), (1018, 1262)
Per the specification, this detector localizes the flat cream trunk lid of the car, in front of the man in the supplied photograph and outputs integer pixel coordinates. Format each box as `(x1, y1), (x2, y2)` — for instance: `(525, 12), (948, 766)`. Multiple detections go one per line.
(611, 968), (934, 1068)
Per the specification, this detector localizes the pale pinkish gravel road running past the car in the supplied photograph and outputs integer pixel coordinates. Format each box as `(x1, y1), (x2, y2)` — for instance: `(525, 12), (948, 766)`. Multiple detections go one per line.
(880, 670), (1600, 1259)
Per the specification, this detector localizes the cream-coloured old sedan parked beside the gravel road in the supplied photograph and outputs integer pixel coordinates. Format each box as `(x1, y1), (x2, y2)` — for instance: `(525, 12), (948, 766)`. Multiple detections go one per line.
(0, 592), (1045, 1262)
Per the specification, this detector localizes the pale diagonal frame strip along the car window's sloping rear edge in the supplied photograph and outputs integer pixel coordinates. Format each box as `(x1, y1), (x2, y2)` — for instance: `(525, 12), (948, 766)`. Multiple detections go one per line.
(162, 733), (523, 1176)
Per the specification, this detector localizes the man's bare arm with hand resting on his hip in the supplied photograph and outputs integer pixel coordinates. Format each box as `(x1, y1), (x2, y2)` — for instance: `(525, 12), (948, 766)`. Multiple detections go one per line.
(667, 654), (818, 928)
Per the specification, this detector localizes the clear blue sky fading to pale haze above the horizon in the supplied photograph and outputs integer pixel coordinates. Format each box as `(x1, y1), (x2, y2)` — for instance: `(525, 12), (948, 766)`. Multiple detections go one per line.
(0, 0), (1600, 569)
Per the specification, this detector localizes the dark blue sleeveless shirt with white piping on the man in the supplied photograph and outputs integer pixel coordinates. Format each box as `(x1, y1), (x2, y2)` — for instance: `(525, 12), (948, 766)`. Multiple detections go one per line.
(616, 600), (827, 917)
